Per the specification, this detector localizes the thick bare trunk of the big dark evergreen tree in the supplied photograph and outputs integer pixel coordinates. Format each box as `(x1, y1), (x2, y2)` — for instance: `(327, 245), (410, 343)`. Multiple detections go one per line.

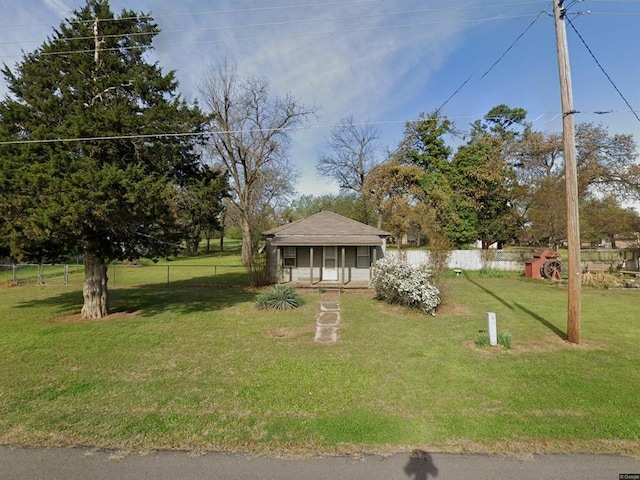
(82, 250), (109, 319)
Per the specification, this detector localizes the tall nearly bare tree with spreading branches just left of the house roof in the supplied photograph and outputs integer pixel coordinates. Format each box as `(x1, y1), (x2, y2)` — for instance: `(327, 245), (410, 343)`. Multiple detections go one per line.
(200, 61), (313, 266)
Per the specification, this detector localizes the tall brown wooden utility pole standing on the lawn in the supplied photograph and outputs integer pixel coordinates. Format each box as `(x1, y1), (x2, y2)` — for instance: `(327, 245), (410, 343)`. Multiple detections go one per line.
(553, 0), (582, 343)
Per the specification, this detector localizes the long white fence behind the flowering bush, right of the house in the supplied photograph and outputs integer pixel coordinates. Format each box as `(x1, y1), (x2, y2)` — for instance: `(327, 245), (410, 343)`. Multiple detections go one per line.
(386, 249), (525, 272)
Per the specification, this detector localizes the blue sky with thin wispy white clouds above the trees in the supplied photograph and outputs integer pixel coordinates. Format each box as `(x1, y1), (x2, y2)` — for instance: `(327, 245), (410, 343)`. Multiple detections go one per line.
(0, 0), (640, 195)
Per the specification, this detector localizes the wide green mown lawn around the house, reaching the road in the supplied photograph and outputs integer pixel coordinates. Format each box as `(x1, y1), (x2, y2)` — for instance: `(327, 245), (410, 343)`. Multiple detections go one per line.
(0, 264), (640, 455)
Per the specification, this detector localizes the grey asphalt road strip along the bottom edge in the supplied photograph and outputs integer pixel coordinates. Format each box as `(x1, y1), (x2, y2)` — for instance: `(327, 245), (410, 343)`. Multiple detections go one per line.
(0, 446), (640, 480)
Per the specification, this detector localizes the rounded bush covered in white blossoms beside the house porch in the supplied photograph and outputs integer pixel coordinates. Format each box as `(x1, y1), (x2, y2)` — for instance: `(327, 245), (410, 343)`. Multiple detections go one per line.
(370, 255), (440, 315)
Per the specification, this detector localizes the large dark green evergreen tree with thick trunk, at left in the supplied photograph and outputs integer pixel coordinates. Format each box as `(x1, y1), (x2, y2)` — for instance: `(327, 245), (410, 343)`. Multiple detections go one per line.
(0, 0), (203, 318)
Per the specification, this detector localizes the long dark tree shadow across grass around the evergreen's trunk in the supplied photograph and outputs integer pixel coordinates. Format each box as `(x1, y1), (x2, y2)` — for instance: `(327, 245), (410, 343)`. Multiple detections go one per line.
(19, 273), (255, 316)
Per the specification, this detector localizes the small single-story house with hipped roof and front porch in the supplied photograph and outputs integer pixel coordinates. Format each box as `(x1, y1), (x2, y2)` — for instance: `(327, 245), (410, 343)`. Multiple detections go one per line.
(262, 211), (389, 286)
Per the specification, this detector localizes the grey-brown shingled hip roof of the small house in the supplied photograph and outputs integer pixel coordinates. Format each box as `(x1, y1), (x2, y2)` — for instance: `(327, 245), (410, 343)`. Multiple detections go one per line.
(262, 212), (389, 246)
